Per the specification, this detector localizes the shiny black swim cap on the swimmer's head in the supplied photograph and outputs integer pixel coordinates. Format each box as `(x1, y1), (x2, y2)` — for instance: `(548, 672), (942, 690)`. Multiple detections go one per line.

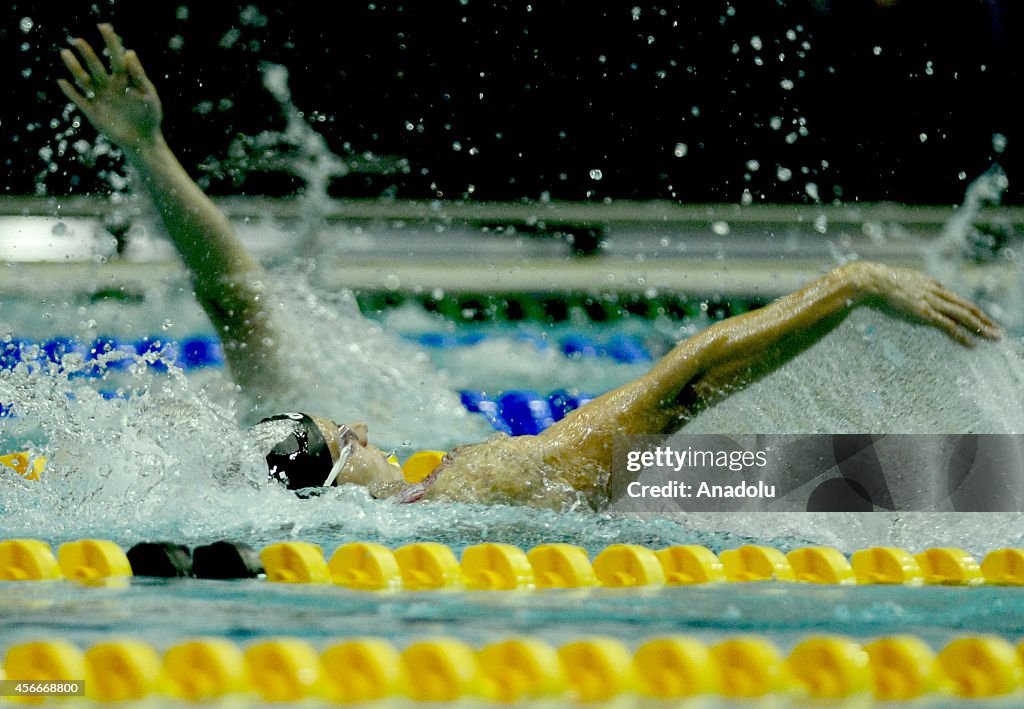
(254, 413), (335, 490)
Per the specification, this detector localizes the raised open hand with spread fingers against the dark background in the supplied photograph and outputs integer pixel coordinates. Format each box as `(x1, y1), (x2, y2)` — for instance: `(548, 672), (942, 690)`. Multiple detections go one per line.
(57, 25), (164, 151)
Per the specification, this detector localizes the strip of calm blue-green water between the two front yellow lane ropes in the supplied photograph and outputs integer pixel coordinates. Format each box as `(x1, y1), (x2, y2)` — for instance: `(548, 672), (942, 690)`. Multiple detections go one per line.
(6, 579), (1024, 648)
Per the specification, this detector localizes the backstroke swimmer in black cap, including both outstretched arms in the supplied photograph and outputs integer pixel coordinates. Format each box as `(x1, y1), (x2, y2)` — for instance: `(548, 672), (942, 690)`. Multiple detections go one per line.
(59, 25), (1001, 509)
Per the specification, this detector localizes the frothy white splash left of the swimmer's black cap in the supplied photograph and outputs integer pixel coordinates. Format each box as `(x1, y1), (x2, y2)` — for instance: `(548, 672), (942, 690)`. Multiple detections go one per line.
(0, 351), (266, 538)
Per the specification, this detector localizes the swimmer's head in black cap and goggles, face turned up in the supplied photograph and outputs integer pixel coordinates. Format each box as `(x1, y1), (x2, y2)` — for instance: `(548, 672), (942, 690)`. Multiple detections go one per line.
(253, 413), (401, 490)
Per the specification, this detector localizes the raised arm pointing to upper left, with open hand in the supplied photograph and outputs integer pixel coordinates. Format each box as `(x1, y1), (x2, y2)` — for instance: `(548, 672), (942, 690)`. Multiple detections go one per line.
(58, 25), (273, 387)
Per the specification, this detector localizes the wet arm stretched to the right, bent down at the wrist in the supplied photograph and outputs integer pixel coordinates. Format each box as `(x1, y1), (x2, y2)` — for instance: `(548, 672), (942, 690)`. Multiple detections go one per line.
(540, 261), (1001, 469)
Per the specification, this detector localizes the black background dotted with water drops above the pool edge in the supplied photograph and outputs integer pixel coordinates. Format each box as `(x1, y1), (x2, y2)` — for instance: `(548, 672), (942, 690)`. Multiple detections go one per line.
(0, 0), (1024, 204)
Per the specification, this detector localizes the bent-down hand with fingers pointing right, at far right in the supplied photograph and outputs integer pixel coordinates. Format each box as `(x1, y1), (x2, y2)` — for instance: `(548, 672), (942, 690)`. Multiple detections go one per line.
(846, 261), (1002, 347)
